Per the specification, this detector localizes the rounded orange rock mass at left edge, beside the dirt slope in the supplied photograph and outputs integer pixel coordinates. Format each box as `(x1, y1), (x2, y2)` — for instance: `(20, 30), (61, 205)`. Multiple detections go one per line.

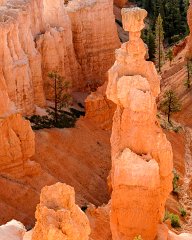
(0, 114), (37, 178)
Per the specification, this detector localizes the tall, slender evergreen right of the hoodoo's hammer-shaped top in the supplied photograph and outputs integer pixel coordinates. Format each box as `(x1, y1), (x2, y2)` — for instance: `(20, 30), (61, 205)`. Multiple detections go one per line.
(155, 14), (165, 72)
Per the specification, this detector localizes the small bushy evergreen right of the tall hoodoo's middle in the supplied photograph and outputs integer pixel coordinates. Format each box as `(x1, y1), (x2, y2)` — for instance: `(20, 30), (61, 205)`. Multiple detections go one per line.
(160, 90), (181, 123)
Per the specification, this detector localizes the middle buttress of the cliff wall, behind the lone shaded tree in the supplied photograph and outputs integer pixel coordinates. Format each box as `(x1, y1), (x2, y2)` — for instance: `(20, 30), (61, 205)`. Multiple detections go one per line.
(36, 0), (84, 99)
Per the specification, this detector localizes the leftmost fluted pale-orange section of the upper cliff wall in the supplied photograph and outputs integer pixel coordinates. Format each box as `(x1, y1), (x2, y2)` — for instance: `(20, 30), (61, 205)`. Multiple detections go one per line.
(0, 0), (45, 114)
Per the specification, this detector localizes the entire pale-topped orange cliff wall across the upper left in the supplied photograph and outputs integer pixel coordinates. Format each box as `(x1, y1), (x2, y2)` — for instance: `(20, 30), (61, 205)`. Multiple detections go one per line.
(0, 0), (119, 114)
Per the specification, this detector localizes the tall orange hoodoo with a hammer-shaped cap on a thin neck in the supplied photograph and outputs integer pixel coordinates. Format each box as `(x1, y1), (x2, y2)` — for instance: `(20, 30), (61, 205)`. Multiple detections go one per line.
(106, 8), (173, 240)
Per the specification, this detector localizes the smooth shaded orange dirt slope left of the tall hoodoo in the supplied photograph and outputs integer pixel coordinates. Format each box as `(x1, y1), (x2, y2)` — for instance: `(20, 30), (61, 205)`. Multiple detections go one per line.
(0, 120), (111, 229)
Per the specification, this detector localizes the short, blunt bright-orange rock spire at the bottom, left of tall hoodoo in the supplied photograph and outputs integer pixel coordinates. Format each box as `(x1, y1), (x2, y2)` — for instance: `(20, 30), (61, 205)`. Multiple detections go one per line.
(32, 183), (90, 240)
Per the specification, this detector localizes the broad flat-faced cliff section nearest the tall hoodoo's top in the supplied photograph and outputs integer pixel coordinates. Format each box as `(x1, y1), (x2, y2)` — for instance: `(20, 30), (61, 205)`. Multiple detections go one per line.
(66, 0), (120, 84)
